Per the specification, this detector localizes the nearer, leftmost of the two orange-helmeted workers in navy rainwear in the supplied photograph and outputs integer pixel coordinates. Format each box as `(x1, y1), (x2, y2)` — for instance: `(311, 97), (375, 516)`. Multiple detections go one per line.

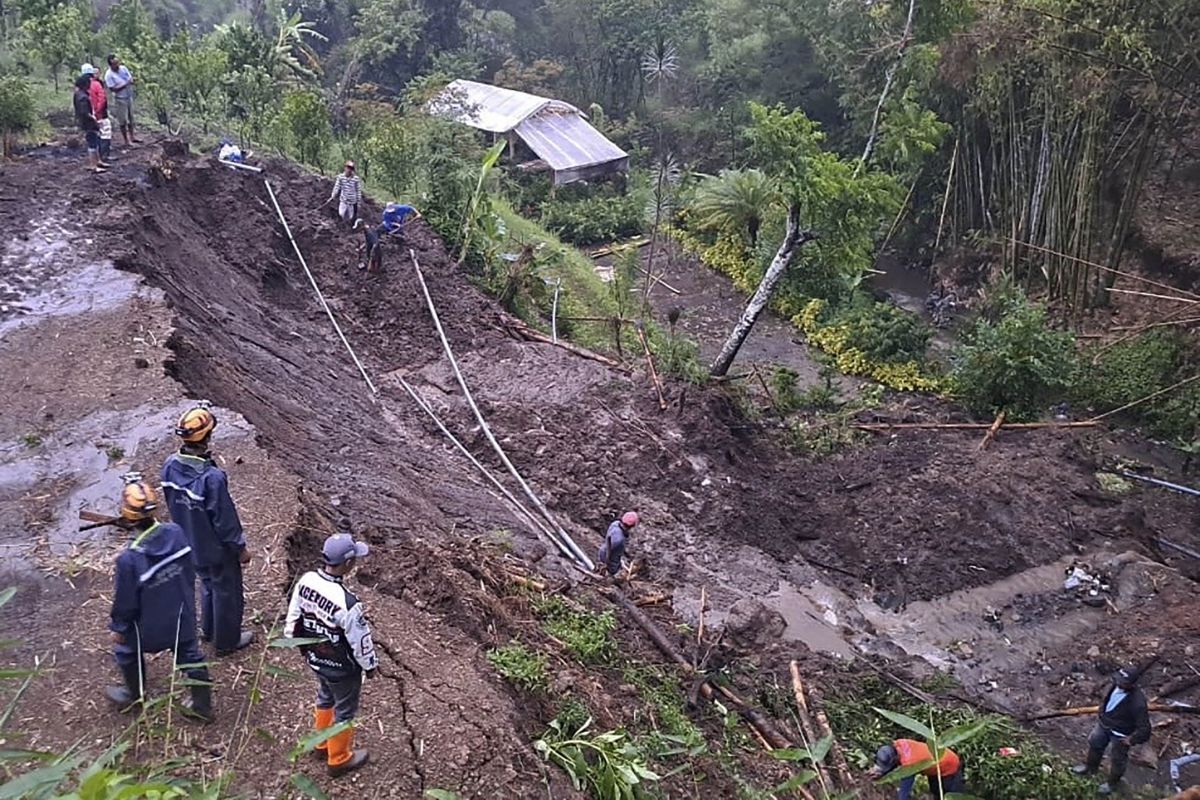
(104, 473), (212, 721)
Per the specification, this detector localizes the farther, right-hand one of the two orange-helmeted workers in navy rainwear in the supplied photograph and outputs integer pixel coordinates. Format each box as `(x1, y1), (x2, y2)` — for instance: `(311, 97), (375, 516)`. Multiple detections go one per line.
(162, 403), (254, 656)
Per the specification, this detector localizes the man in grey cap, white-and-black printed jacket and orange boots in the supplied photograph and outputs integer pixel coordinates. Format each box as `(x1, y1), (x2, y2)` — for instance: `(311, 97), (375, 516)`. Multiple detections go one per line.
(283, 534), (379, 777)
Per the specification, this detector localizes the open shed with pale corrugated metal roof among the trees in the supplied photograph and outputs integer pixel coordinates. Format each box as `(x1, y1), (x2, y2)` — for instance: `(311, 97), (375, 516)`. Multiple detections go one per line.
(430, 80), (629, 186)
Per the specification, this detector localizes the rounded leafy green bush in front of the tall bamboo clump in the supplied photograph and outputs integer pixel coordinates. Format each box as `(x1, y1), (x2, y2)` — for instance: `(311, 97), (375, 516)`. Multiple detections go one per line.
(952, 293), (1075, 422)
